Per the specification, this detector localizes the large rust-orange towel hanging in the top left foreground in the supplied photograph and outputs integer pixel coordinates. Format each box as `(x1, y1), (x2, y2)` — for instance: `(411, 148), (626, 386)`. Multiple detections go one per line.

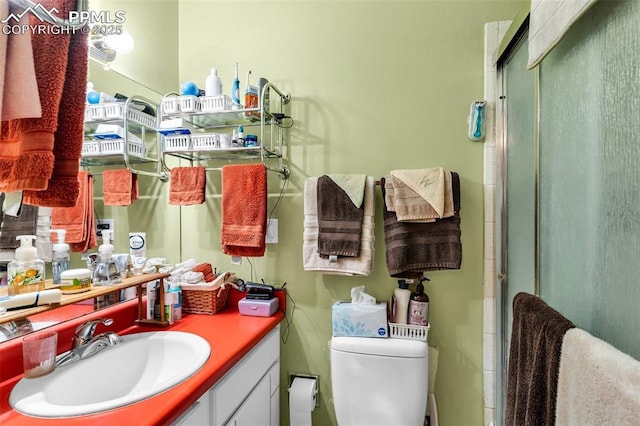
(0, 0), (88, 207)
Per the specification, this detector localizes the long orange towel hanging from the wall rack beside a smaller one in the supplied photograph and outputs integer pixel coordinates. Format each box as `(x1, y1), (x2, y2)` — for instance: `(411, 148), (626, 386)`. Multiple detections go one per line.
(221, 164), (267, 256)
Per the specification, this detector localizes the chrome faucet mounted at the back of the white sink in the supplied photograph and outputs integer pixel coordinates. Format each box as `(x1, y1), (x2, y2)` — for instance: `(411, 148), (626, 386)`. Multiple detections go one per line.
(56, 318), (122, 367)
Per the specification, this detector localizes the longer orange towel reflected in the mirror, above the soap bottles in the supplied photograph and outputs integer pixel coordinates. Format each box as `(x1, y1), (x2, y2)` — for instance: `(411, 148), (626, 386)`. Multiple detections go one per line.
(51, 171), (97, 252)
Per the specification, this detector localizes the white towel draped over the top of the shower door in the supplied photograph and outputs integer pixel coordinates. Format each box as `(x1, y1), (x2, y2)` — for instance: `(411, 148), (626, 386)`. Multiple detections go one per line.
(528, 0), (596, 69)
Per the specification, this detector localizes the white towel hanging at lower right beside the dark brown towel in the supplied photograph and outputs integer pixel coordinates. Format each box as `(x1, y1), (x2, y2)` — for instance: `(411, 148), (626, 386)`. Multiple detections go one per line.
(556, 328), (640, 426)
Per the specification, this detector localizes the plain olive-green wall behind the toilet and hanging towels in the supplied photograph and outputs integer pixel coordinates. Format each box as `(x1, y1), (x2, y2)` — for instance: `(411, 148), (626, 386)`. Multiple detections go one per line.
(92, 0), (520, 426)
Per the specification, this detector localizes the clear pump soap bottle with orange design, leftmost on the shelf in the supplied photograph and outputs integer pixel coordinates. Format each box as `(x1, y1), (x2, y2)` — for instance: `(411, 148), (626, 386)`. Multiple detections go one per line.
(7, 235), (45, 296)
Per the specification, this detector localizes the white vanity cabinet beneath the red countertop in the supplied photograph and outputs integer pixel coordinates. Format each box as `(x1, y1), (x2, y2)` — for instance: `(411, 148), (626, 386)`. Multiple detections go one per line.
(174, 325), (280, 426)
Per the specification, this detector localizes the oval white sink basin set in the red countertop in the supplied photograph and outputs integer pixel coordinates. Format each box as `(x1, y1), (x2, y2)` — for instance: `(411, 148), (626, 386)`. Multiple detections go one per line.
(9, 331), (211, 417)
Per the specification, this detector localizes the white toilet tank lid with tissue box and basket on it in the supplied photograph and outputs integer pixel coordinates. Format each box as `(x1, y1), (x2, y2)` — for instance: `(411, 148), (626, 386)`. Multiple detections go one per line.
(331, 336), (428, 358)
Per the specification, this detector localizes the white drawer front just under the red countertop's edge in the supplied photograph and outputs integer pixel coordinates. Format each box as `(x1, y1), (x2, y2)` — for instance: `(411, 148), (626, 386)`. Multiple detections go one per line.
(213, 326), (280, 425)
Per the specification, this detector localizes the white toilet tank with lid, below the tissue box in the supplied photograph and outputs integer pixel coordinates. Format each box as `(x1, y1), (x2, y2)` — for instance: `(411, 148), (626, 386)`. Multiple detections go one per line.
(331, 337), (429, 426)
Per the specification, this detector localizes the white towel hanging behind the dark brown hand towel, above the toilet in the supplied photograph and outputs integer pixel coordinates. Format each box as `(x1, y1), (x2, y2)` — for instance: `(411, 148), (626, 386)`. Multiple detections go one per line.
(302, 176), (375, 276)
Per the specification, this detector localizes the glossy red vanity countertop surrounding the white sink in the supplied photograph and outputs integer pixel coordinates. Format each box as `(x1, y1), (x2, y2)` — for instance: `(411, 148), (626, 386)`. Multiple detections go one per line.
(0, 295), (284, 426)
